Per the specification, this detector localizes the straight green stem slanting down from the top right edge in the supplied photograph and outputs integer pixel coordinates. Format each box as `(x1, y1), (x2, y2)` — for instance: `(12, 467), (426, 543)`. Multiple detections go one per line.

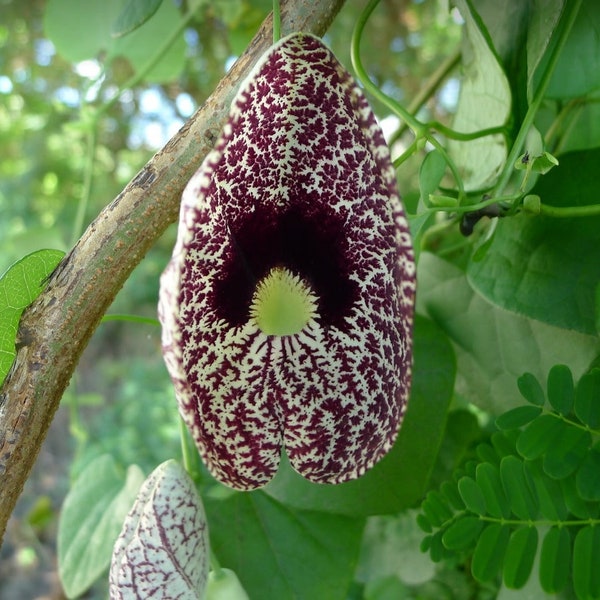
(494, 0), (582, 195)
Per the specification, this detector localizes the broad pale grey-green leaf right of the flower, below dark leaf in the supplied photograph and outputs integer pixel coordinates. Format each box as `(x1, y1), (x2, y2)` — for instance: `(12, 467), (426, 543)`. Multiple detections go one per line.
(417, 251), (600, 415)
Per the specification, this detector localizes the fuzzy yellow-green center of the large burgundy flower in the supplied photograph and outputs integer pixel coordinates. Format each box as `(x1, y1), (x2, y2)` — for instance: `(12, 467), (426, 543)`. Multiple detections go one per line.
(250, 267), (317, 335)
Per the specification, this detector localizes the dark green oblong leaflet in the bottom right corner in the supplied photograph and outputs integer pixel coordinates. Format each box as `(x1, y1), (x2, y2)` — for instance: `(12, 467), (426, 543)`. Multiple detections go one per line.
(573, 525), (600, 598)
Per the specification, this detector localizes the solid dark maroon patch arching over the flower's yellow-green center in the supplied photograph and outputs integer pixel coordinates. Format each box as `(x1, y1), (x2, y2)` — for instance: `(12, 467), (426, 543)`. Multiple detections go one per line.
(215, 204), (357, 329)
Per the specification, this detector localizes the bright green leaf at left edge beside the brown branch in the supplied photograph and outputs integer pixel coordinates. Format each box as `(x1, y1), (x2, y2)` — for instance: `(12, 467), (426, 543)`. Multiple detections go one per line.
(0, 250), (65, 385)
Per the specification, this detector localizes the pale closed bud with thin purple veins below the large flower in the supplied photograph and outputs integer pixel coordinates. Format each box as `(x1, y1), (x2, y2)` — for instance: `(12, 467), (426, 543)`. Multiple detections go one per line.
(110, 460), (210, 600)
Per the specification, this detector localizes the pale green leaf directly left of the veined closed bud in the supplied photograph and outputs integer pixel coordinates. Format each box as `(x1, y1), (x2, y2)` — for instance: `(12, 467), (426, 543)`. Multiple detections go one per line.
(57, 454), (144, 598)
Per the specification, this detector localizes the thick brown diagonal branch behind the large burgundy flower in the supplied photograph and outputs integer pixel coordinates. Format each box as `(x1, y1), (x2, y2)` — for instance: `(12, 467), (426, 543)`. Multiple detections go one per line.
(0, 0), (344, 540)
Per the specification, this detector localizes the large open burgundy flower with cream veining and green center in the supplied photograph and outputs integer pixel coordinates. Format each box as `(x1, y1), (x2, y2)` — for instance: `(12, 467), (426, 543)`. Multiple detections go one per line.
(159, 33), (415, 490)
